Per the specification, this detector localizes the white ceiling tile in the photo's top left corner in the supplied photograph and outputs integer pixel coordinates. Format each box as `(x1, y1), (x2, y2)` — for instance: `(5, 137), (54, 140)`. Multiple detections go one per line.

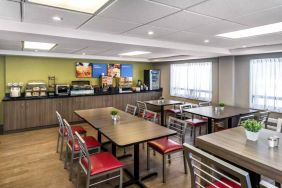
(0, 0), (21, 22)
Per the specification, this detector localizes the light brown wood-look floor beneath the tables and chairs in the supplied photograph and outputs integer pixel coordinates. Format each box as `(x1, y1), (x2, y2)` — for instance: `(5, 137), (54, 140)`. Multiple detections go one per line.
(0, 124), (197, 188)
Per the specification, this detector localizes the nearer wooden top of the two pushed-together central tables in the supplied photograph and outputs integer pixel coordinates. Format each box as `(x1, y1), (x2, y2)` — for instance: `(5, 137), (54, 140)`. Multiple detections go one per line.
(100, 118), (176, 147)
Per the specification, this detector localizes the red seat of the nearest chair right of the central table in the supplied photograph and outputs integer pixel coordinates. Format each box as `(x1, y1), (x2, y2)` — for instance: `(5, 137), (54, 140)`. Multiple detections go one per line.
(148, 138), (183, 154)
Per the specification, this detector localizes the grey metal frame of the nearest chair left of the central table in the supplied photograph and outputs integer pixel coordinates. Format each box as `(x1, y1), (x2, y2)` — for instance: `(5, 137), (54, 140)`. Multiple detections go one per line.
(75, 132), (123, 188)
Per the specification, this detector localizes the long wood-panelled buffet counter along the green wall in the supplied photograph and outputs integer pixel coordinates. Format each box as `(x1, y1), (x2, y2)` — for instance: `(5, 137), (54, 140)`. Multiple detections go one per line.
(3, 90), (162, 132)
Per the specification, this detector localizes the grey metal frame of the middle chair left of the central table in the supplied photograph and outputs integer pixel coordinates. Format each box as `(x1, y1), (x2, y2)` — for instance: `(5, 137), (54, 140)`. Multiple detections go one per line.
(63, 119), (101, 181)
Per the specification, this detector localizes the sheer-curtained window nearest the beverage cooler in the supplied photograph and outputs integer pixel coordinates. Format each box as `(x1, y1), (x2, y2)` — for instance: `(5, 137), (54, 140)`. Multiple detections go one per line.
(170, 62), (212, 101)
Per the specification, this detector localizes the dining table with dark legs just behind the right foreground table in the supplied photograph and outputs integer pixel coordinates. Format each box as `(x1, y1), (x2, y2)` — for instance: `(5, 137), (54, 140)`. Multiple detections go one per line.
(184, 106), (258, 133)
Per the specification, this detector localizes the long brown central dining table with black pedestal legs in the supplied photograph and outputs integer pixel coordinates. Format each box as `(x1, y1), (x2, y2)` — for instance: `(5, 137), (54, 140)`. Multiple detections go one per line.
(75, 107), (177, 187)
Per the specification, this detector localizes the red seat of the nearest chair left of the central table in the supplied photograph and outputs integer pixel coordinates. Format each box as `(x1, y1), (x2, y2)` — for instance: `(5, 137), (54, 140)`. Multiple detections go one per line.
(82, 152), (123, 176)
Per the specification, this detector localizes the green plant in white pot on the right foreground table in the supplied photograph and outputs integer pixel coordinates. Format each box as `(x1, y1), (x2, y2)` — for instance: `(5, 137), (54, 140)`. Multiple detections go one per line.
(241, 119), (262, 141)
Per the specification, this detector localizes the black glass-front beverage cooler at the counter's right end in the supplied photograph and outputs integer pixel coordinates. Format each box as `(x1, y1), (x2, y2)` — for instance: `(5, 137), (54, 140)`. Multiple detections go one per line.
(144, 70), (161, 90)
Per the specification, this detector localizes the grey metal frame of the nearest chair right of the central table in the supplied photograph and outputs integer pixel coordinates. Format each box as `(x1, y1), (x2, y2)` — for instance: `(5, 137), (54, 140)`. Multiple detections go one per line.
(147, 116), (187, 183)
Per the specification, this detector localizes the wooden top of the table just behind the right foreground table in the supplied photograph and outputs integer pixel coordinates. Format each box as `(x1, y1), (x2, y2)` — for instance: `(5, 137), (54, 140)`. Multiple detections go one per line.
(185, 106), (257, 119)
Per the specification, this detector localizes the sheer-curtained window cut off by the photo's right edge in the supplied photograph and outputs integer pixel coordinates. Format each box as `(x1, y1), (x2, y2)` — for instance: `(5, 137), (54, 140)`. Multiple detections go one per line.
(250, 58), (282, 112)
